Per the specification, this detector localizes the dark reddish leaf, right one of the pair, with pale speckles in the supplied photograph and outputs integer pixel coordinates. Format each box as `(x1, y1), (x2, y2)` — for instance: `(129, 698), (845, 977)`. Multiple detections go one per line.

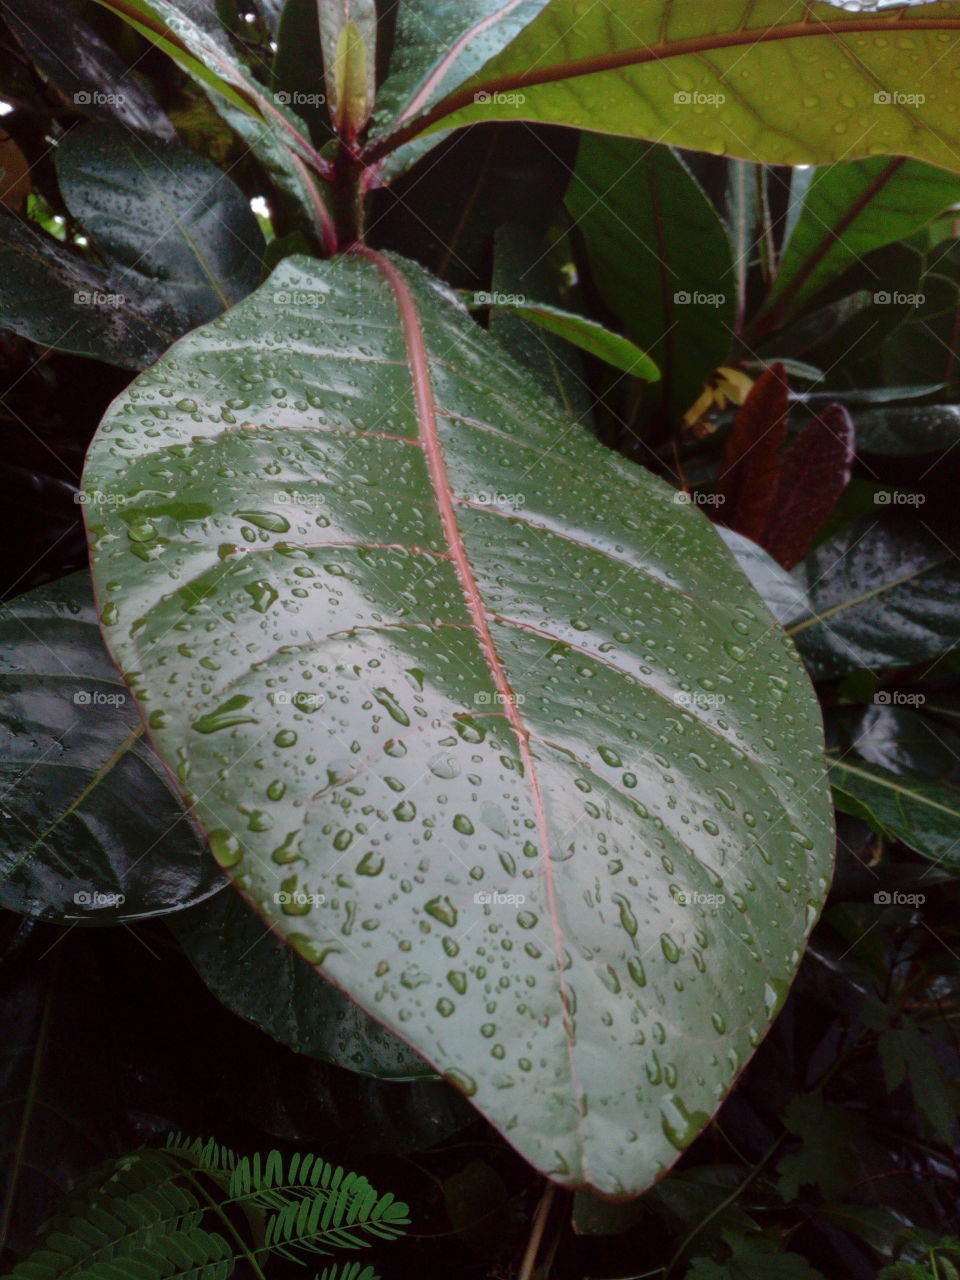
(759, 404), (855, 568)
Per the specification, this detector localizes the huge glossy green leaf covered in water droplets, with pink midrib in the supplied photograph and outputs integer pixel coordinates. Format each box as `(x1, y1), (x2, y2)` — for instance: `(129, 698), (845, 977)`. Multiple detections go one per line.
(86, 251), (832, 1194)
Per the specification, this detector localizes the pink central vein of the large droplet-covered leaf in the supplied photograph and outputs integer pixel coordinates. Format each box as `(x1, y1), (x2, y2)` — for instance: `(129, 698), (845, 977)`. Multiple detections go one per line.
(353, 244), (585, 1146)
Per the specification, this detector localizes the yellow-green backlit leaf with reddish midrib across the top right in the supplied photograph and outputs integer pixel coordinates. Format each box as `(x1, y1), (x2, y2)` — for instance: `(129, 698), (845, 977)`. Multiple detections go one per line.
(366, 0), (960, 169)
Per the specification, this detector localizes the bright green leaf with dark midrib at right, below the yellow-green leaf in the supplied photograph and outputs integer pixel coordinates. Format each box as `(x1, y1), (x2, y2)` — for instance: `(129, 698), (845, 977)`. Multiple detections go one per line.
(759, 156), (960, 329)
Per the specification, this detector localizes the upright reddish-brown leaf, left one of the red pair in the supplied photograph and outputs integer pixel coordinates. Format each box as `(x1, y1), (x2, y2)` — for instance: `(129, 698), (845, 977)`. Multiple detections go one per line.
(717, 364), (790, 543)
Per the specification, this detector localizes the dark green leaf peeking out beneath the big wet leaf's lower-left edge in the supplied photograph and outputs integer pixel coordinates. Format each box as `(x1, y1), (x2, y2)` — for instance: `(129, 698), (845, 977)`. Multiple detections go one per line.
(166, 890), (435, 1080)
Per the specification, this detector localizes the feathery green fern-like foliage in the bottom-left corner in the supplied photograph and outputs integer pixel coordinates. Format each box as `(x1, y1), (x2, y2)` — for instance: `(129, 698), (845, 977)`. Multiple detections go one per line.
(9, 1134), (410, 1280)
